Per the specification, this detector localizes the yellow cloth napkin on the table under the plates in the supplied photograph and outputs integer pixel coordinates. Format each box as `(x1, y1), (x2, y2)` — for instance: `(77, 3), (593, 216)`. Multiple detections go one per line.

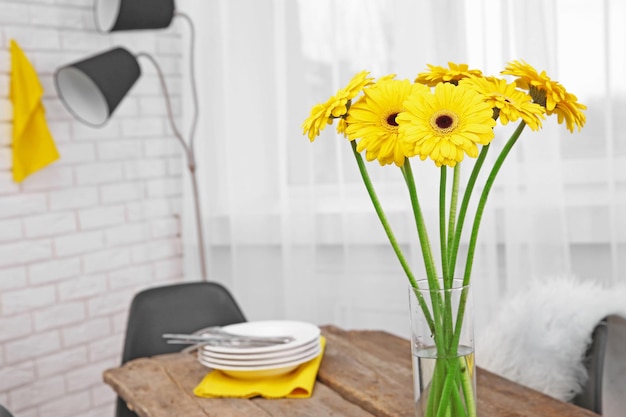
(193, 336), (326, 398)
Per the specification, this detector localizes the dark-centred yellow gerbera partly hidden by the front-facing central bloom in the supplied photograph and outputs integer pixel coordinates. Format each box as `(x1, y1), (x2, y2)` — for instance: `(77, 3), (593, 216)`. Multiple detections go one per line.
(345, 77), (428, 166)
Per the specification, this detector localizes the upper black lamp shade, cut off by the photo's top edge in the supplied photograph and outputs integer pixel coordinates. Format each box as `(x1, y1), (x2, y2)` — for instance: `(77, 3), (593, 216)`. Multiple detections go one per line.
(95, 0), (174, 32)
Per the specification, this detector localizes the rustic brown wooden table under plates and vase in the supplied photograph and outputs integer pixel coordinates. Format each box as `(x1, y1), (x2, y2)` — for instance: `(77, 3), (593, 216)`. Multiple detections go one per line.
(103, 326), (598, 417)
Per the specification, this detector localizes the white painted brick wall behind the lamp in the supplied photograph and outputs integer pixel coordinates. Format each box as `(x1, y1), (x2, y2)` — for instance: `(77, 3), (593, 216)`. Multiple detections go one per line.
(0, 0), (185, 417)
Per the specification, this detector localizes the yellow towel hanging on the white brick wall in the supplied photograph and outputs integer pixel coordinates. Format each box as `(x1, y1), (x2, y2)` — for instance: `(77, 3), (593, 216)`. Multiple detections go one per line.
(10, 39), (59, 182)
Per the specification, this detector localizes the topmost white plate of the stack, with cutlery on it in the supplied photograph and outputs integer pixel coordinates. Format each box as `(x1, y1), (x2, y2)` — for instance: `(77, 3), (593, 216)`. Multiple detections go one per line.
(203, 320), (320, 355)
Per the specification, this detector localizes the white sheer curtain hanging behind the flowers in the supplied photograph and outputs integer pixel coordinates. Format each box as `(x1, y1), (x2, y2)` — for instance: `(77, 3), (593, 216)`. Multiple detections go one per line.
(183, 0), (626, 334)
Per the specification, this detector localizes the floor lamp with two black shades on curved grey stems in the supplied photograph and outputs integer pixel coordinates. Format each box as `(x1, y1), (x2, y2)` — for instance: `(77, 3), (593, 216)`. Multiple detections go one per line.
(54, 0), (208, 281)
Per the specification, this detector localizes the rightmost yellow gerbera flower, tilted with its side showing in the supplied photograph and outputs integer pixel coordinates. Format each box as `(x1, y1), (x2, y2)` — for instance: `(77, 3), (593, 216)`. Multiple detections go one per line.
(502, 61), (587, 132)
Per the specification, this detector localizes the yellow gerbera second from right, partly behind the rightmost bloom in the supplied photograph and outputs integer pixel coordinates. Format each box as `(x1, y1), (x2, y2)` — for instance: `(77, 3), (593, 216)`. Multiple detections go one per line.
(459, 77), (545, 130)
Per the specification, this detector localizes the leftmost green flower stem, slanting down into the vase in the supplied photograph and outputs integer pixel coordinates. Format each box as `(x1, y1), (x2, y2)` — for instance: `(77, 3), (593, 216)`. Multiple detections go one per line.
(350, 141), (435, 332)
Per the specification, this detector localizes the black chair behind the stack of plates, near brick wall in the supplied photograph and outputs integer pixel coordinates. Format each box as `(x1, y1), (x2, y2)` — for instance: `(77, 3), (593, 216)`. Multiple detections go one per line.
(116, 282), (246, 417)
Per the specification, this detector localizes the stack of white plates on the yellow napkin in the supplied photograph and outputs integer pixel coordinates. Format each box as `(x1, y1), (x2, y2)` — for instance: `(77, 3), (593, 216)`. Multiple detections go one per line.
(198, 320), (320, 379)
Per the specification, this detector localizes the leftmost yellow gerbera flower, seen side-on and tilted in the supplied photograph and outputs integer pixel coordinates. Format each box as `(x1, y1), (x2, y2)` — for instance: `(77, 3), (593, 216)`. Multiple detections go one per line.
(302, 71), (373, 142)
